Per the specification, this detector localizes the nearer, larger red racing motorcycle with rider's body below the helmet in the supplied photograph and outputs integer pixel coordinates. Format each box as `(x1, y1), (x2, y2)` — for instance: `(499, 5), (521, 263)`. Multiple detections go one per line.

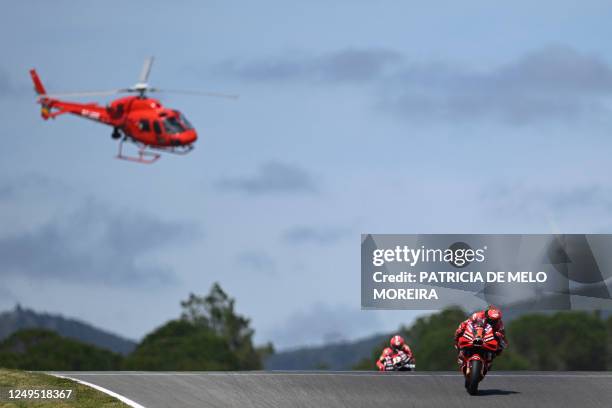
(457, 320), (499, 395)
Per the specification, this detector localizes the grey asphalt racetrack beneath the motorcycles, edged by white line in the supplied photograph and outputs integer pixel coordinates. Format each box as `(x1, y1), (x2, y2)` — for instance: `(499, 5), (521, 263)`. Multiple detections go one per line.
(53, 371), (612, 408)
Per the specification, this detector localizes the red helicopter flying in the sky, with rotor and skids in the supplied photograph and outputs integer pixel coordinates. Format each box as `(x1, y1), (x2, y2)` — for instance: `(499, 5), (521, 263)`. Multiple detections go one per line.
(30, 57), (238, 164)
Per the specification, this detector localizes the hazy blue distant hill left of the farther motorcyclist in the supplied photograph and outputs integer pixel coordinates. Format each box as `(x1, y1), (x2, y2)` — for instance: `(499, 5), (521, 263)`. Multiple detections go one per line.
(264, 333), (391, 370)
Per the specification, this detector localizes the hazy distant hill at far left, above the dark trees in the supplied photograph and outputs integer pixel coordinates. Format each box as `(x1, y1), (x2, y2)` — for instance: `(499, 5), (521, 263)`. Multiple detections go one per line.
(0, 305), (136, 355)
